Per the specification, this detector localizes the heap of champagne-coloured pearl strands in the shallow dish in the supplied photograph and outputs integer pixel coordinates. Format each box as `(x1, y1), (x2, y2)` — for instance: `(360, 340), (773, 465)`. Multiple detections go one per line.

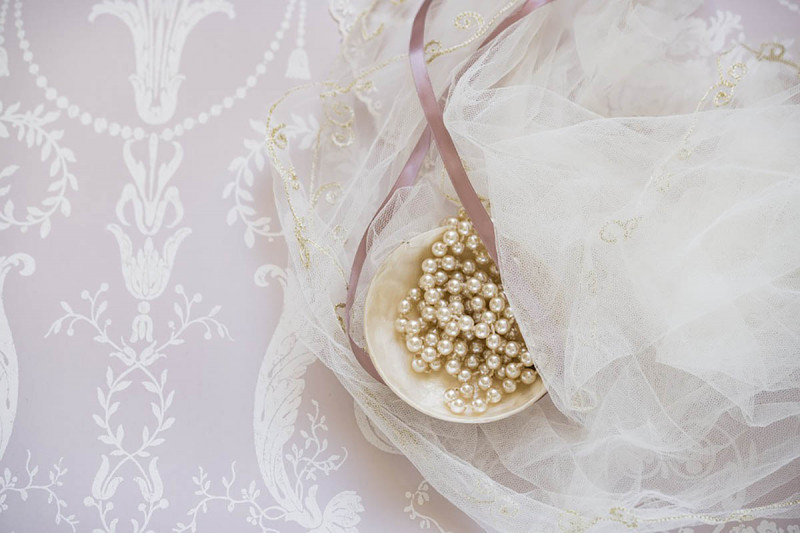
(395, 209), (536, 414)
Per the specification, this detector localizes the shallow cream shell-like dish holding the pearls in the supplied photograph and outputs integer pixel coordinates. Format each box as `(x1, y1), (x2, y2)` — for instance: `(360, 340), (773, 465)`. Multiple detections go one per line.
(364, 228), (547, 424)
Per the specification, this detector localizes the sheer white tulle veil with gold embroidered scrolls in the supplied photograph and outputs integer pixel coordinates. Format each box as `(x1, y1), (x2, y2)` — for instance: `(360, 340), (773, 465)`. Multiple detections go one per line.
(268, 0), (800, 532)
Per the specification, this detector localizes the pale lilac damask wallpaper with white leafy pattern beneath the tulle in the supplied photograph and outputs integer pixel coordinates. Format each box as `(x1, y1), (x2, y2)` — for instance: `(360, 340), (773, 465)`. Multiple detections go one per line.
(0, 0), (800, 533)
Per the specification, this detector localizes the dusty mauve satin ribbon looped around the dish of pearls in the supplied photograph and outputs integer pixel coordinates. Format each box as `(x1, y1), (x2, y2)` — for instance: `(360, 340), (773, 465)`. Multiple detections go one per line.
(345, 0), (553, 383)
